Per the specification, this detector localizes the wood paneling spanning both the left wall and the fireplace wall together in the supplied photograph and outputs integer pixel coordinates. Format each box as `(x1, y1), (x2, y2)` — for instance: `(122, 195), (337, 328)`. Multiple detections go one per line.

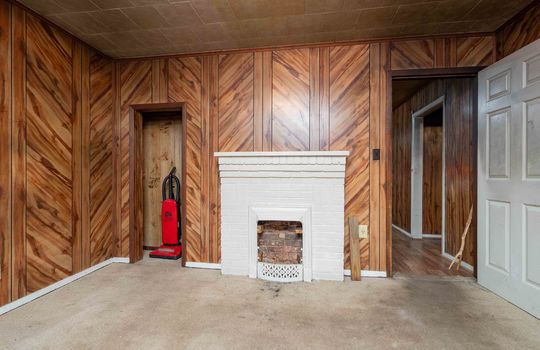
(0, 0), (500, 304)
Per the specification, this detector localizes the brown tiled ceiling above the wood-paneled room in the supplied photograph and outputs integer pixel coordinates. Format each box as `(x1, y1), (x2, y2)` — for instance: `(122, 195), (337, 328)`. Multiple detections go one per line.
(14, 0), (531, 58)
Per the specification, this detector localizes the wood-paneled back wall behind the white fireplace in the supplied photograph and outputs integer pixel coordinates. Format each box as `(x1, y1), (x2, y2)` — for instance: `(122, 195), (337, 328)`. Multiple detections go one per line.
(118, 36), (495, 270)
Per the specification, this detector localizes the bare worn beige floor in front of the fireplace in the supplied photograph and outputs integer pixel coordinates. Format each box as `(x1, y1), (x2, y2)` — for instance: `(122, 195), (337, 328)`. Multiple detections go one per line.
(0, 260), (540, 349)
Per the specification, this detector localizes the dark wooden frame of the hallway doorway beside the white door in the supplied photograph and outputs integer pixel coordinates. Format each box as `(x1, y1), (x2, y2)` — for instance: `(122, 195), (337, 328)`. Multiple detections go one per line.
(384, 66), (485, 277)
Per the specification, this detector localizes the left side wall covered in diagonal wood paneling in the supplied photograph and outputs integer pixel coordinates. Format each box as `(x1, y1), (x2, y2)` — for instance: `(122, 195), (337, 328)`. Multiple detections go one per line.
(0, 1), (115, 305)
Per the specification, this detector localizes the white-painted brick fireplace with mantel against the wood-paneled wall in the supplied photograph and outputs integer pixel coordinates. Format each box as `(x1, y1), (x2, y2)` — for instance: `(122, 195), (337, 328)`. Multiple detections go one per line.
(215, 151), (349, 281)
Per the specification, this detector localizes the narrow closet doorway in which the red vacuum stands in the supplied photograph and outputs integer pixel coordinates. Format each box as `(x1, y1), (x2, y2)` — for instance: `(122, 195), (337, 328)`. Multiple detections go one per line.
(129, 103), (186, 265)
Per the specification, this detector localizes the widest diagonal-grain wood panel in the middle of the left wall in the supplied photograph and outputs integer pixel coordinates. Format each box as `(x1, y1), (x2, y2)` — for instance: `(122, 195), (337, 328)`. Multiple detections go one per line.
(25, 16), (74, 292)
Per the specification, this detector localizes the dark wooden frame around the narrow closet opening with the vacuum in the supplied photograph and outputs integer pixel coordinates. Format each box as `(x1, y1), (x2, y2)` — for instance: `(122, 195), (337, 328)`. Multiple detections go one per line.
(129, 102), (187, 266)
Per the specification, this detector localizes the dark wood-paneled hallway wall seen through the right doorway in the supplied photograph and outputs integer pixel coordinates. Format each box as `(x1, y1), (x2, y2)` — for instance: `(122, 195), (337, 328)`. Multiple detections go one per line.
(393, 78), (477, 266)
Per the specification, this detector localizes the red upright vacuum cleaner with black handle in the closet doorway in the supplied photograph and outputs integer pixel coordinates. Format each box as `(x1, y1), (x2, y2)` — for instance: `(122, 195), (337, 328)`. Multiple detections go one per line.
(150, 167), (182, 260)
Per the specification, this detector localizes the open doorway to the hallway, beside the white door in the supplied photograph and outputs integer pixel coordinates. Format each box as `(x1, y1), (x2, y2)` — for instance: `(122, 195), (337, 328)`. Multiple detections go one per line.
(392, 73), (477, 277)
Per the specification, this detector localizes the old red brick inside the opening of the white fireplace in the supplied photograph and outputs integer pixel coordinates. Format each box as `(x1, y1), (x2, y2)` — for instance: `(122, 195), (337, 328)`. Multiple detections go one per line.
(257, 221), (302, 264)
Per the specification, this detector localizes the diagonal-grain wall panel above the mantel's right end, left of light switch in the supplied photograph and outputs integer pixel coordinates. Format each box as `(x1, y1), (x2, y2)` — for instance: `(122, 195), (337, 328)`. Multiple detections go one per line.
(329, 45), (370, 269)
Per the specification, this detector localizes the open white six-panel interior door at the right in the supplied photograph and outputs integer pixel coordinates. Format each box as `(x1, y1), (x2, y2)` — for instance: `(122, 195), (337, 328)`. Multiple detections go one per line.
(478, 40), (540, 318)
